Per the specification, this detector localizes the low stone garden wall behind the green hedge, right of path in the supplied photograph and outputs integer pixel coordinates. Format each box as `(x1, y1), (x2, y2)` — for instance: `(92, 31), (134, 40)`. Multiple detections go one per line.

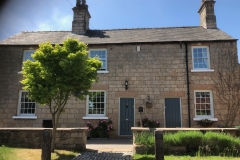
(131, 127), (240, 154)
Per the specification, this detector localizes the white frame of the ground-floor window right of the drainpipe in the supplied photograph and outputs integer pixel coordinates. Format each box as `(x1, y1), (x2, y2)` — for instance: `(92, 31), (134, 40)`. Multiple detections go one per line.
(193, 90), (218, 121)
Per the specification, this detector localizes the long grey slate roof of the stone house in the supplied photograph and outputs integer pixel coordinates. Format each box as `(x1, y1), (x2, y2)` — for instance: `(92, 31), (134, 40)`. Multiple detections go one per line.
(0, 26), (236, 45)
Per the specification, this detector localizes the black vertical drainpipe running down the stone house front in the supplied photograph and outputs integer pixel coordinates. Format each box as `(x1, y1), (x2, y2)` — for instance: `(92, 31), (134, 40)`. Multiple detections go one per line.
(184, 42), (191, 128)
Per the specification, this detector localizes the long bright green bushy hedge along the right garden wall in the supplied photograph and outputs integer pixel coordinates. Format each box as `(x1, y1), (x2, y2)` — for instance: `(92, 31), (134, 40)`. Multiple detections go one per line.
(135, 131), (240, 156)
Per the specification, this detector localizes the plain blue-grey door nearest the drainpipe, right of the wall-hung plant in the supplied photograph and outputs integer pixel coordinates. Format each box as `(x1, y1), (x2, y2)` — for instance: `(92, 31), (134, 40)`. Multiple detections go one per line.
(165, 98), (182, 128)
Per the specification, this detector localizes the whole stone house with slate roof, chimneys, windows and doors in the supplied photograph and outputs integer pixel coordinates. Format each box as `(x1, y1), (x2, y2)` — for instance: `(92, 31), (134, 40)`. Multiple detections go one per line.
(0, 0), (238, 137)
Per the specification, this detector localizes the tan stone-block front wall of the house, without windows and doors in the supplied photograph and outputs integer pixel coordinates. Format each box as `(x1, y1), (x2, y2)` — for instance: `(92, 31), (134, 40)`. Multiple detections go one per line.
(0, 42), (238, 137)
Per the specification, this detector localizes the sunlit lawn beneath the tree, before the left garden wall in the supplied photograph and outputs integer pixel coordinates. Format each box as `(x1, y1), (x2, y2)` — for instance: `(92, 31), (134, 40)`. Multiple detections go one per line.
(0, 146), (79, 160)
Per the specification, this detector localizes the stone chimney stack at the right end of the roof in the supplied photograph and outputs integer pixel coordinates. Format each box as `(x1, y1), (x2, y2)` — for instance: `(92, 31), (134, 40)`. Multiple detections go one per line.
(198, 0), (217, 29)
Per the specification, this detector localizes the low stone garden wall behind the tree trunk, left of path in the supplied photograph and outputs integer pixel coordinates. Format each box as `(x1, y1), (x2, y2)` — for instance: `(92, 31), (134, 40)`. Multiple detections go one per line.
(0, 128), (88, 151)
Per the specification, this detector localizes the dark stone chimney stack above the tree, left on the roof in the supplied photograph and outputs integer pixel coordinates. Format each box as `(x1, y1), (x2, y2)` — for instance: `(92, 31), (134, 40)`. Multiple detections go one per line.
(72, 0), (91, 34)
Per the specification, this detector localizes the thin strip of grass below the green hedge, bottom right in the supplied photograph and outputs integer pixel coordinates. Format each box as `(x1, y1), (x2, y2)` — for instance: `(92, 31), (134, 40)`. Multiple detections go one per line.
(133, 154), (239, 160)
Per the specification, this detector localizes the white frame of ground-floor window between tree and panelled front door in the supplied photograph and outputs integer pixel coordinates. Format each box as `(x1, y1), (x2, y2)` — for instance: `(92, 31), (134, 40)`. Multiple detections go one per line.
(83, 90), (108, 119)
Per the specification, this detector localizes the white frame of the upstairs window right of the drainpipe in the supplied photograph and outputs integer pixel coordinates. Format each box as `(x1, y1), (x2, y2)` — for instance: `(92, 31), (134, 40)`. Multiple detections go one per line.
(191, 46), (214, 72)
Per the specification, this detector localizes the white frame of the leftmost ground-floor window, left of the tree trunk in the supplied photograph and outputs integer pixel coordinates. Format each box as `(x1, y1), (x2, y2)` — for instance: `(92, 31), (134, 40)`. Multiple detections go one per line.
(13, 90), (37, 119)
